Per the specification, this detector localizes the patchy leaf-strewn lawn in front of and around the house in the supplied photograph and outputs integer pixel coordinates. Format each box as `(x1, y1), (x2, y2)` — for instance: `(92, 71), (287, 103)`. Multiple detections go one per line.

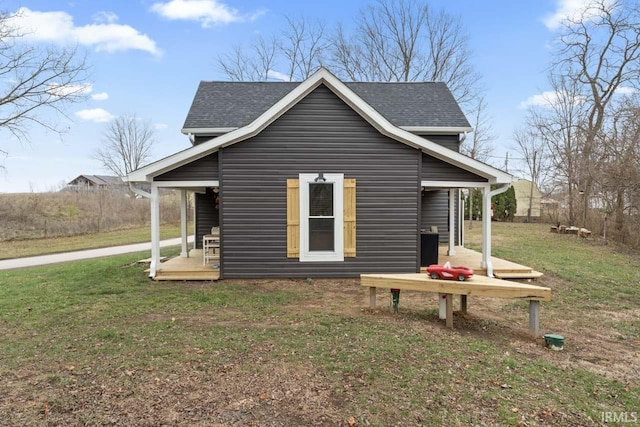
(0, 224), (640, 426)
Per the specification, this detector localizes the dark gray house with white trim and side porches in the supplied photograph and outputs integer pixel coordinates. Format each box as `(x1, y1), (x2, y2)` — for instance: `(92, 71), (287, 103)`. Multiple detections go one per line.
(127, 69), (511, 278)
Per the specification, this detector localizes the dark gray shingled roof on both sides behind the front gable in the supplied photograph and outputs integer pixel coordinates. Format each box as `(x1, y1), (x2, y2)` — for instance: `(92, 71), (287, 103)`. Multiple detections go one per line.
(182, 81), (472, 134)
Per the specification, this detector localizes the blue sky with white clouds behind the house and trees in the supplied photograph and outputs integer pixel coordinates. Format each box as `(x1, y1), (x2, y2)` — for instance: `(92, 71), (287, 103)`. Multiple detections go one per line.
(0, 0), (584, 193)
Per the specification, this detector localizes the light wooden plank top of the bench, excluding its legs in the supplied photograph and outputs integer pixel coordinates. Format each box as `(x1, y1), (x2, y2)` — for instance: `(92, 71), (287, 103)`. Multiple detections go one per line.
(360, 273), (551, 301)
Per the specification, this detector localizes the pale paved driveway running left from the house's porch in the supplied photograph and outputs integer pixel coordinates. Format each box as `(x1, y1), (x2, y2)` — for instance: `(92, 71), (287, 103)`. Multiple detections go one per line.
(0, 236), (193, 270)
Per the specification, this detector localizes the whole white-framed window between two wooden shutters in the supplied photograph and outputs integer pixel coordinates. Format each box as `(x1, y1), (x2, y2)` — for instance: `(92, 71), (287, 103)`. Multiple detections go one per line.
(300, 174), (344, 261)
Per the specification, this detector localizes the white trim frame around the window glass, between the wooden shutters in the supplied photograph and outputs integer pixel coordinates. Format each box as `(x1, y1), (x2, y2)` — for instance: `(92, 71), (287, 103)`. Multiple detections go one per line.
(298, 173), (344, 262)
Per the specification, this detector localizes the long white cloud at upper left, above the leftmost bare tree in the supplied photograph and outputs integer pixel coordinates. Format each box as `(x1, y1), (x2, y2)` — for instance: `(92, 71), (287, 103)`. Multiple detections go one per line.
(11, 7), (162, 55)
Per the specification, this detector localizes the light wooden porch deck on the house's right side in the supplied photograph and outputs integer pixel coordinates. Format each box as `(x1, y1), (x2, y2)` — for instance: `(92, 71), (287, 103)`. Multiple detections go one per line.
(420, 246), (542, 279)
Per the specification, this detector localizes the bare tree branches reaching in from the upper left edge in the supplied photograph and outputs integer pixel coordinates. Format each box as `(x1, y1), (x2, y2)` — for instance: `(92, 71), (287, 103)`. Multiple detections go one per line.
(0, 10), (87, 154)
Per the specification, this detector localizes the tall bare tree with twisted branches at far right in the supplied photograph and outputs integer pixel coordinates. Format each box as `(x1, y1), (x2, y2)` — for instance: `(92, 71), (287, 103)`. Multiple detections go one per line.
(552, 0), (640, 229)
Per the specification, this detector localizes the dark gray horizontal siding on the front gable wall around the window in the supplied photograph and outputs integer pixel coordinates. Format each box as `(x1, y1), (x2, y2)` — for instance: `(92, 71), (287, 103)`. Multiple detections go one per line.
(221, 86), (421, 278)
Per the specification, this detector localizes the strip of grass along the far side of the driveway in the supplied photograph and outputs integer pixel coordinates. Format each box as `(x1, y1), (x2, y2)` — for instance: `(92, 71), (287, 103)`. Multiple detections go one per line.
(0, 225), (180, 259)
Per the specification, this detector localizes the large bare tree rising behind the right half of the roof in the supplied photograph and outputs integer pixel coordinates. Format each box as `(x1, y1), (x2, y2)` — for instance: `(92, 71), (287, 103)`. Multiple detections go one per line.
(331, 0), (479, 106)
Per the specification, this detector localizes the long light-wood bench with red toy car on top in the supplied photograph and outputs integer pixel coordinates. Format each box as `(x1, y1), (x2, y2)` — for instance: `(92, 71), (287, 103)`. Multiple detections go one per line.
(360, 273), (551, 337)
